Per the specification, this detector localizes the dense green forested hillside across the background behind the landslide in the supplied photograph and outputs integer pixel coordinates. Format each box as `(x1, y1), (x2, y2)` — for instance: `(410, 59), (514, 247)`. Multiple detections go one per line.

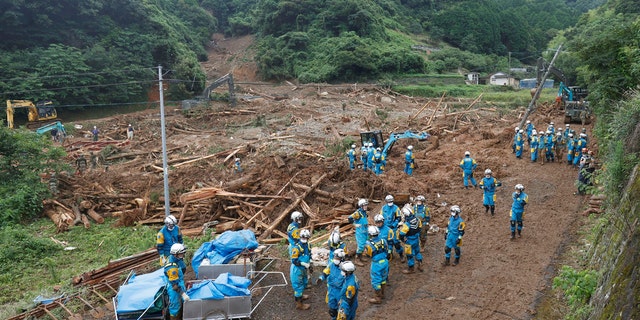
(0, 0), (604, 106)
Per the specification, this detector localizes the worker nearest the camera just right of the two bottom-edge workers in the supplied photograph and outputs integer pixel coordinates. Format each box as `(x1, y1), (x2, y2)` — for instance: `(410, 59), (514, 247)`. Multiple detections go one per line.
(365, 226), (391, 304)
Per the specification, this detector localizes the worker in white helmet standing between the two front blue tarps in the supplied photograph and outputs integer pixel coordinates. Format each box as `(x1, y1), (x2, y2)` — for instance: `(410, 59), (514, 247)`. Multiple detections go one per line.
(164, 243), (190, 320)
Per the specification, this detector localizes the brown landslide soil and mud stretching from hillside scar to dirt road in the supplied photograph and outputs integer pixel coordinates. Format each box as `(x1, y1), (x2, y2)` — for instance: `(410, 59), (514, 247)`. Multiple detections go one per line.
(47, 37), (591, 319)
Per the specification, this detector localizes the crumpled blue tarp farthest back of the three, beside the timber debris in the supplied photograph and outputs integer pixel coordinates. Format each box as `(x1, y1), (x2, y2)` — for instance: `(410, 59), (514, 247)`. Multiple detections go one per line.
(191, 230), (258, 278)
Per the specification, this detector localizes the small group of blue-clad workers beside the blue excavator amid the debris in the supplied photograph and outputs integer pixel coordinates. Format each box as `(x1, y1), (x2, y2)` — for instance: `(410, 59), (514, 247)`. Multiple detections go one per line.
(347, 142), (416, 175)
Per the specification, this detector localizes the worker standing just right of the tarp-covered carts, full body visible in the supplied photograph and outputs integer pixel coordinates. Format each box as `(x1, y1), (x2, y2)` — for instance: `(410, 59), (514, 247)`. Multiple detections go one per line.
(289, 229), (313, 310)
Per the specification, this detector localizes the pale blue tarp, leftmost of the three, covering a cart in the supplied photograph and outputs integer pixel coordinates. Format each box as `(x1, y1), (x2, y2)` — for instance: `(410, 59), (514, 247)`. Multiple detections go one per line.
(116, 268), (166, 313)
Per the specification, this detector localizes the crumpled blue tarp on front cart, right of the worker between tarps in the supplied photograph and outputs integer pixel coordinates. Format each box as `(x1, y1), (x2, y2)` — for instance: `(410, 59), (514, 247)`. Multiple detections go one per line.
(187, 272), (251, 300)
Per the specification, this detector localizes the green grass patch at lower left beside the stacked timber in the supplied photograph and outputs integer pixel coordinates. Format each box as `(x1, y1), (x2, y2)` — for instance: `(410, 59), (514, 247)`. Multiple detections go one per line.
(0, 219), (209, 319)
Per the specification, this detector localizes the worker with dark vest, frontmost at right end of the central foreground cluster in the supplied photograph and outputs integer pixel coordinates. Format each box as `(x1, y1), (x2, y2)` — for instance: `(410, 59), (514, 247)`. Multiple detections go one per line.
(398, 206), (424, 274)
